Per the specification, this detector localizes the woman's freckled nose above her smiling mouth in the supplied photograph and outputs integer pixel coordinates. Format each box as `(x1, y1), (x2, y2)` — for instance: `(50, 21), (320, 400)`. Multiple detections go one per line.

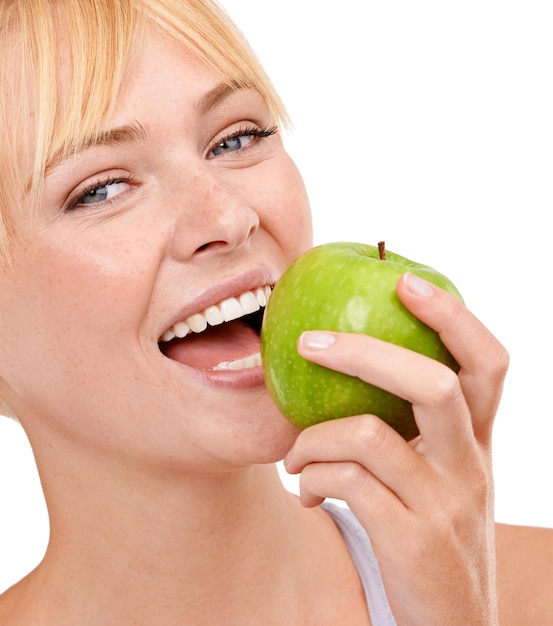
(171, 168), (259, 260)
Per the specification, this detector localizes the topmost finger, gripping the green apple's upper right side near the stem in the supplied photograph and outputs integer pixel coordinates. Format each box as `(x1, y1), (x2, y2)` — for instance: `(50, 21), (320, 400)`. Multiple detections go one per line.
(397, 274), (509, 443)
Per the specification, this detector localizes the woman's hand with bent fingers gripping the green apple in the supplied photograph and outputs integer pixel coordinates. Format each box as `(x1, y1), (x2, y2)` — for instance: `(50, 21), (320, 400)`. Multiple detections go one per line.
(285, 274), (508, 626)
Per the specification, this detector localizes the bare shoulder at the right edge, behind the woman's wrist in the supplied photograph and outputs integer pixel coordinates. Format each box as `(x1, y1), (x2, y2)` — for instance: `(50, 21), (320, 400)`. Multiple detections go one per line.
(496, 524), (553, 626)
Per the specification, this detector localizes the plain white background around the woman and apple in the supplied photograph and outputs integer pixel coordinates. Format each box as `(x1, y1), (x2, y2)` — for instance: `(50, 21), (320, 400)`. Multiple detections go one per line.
(0, 0), (553, 590)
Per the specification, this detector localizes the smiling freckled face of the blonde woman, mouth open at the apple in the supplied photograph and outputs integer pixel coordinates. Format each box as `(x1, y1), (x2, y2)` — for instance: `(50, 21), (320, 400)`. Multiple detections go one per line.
(0, 28), (311, 465)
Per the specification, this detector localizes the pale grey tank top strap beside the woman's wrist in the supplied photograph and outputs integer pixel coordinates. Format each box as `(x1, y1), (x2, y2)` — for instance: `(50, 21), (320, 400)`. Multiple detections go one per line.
(321, 502), (397, 626)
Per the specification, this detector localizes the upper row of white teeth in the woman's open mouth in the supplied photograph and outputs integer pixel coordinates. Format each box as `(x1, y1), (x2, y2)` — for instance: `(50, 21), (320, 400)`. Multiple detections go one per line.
(160, 286), (271, 342)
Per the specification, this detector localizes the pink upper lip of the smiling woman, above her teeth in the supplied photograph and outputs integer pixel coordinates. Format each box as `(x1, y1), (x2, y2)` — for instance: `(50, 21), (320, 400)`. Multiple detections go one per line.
(159, 270), (277, 341)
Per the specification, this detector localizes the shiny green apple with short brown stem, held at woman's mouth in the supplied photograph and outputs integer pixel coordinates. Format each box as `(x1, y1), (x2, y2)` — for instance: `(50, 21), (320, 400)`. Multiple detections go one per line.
(261, 242), (462, 439)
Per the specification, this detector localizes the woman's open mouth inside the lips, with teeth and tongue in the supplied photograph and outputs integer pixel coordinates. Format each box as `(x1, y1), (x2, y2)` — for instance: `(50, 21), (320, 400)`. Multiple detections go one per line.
(158, 285), (272, 371)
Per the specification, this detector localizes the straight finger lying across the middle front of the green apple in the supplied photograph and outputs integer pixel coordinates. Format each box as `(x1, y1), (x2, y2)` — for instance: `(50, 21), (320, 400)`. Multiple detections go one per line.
(298, 331), (473, 463)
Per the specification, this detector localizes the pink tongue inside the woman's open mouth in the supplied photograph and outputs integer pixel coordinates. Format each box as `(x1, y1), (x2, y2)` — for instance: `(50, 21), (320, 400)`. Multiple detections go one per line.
(161, 320), (259, 369)
